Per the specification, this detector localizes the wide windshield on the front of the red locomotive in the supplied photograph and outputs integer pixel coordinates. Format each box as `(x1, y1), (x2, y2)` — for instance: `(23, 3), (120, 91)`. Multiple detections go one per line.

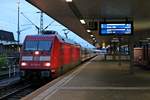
(24, 40), (51, 51)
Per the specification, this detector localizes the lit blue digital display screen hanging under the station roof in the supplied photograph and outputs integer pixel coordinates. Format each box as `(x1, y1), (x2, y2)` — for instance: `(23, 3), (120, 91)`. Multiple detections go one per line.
(99, 23), (132, 35)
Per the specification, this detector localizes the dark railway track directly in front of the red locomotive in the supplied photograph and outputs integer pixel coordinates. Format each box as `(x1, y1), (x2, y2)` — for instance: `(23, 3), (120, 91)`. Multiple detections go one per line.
(0, 82), (38, 100)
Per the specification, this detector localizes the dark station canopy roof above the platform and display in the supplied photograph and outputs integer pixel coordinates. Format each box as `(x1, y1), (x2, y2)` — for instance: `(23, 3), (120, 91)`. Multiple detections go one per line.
(27, 0), (150, 43)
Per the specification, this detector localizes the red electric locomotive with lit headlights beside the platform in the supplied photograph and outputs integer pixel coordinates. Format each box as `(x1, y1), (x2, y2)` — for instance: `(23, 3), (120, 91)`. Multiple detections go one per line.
(20, 32), (91, 78)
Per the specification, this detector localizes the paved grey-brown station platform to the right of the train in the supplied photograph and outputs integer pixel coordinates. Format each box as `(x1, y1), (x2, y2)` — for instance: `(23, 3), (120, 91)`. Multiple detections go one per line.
(22, 55), (150, 100)
